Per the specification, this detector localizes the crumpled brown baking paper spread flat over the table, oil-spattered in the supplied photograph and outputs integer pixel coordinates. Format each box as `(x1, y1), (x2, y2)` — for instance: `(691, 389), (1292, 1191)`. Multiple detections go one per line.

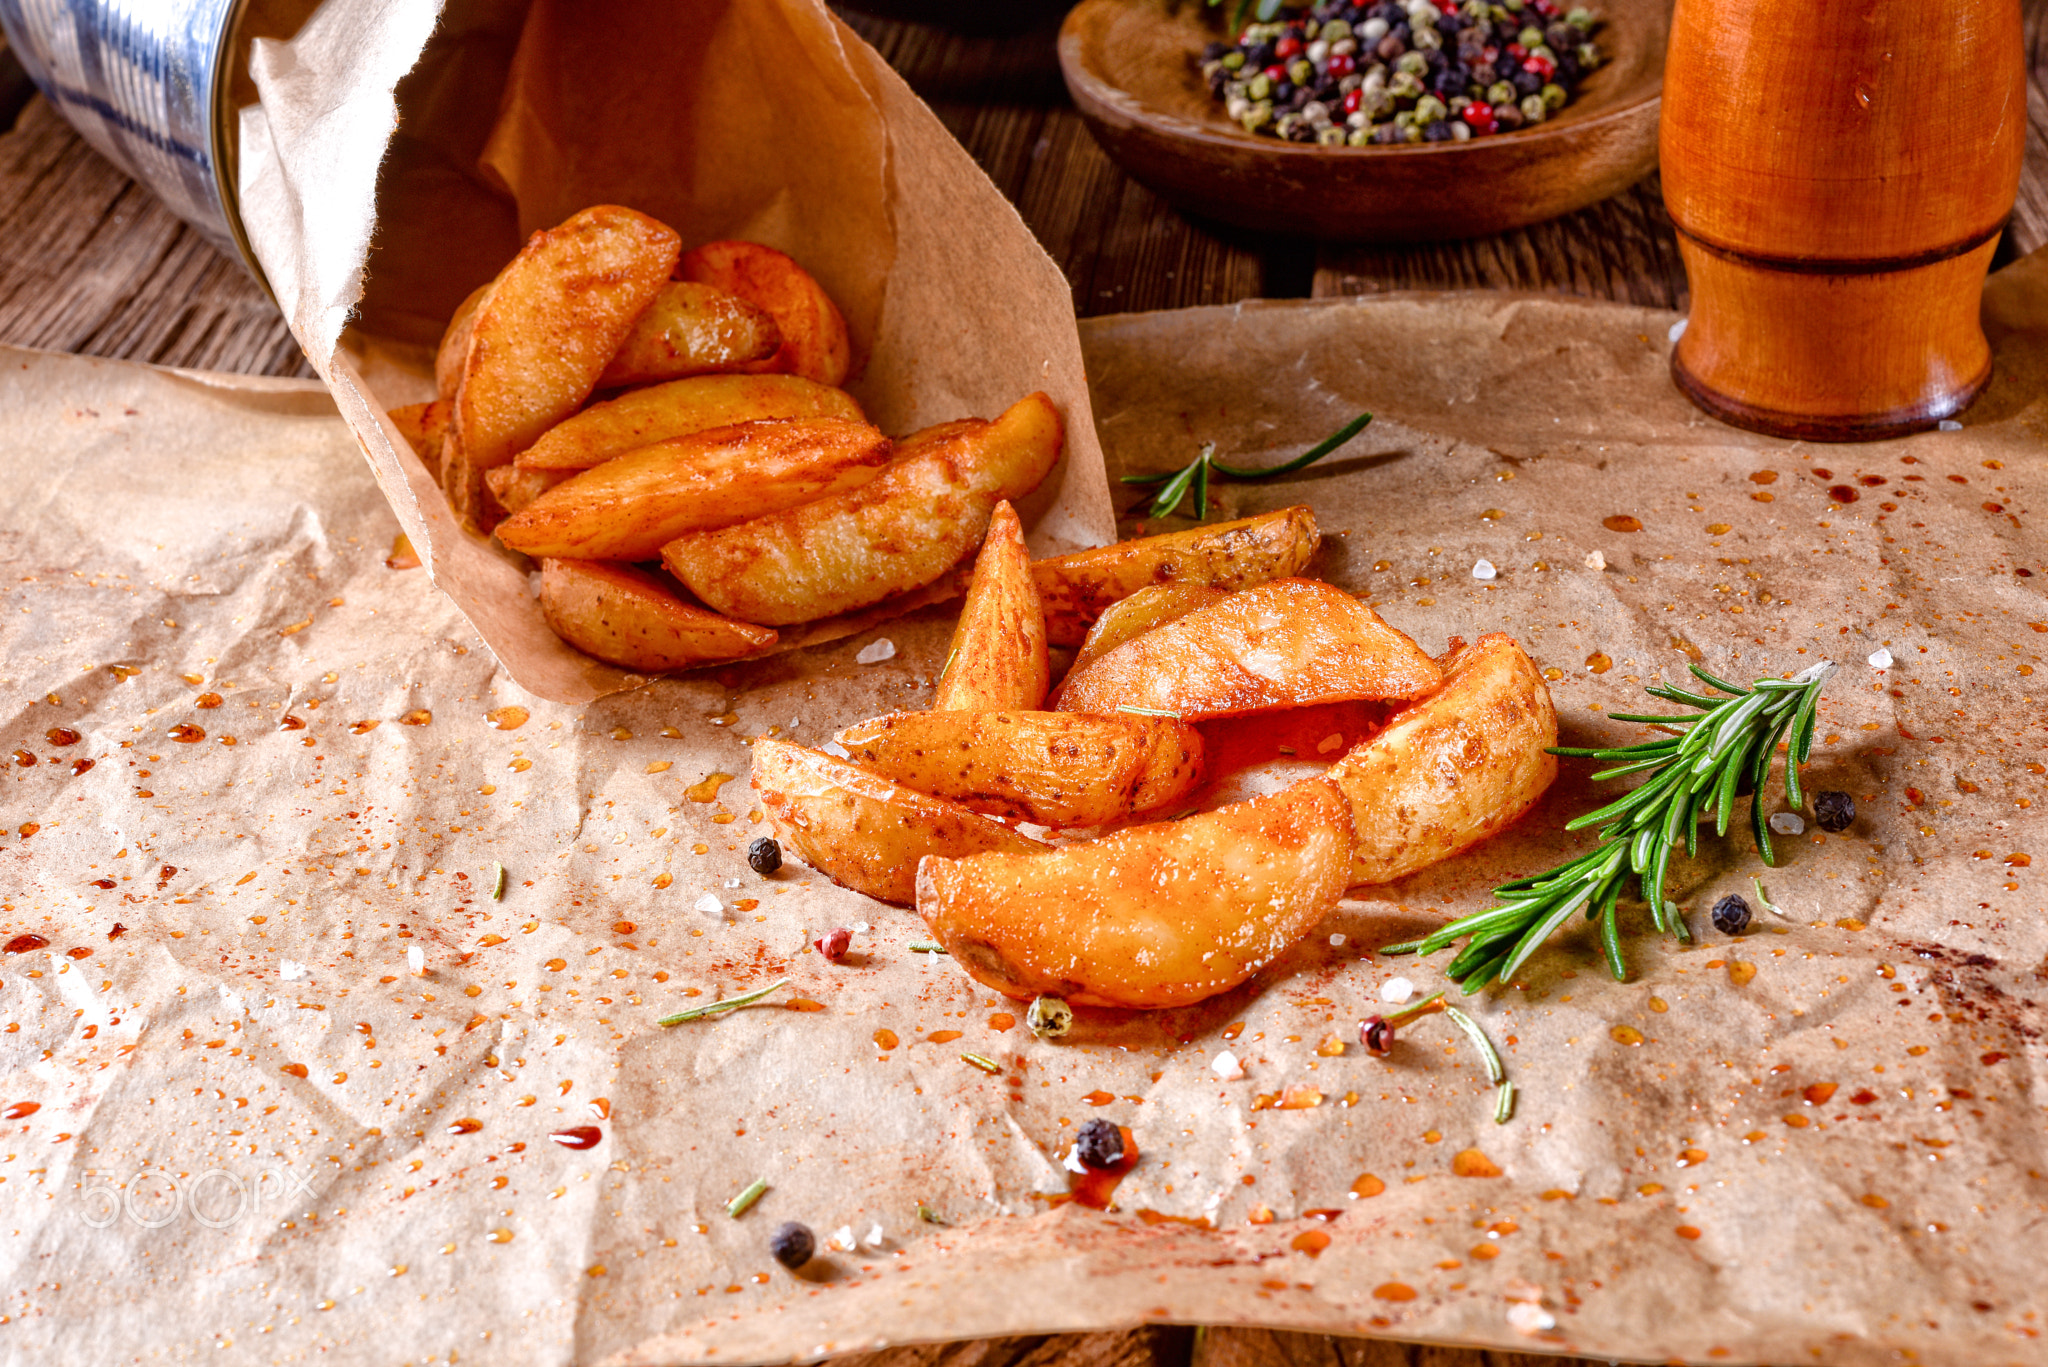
(0, 245), (2048, 1367)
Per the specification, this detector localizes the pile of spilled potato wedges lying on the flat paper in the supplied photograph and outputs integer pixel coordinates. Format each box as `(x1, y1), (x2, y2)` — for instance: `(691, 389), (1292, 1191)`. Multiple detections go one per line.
(752, 504), (1556, 1008)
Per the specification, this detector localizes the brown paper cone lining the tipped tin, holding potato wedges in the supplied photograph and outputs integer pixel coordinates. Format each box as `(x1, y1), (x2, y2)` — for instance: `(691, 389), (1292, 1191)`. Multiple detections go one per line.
(240, 0), (1114, 703)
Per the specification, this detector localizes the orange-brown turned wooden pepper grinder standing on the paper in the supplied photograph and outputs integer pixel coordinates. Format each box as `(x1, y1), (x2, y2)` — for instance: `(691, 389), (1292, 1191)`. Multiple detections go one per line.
(1659, 0), (2028, 441)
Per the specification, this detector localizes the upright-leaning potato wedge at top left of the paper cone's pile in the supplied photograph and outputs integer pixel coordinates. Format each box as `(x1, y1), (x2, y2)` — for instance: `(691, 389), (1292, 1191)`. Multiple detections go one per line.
(442, 205), (682, 516)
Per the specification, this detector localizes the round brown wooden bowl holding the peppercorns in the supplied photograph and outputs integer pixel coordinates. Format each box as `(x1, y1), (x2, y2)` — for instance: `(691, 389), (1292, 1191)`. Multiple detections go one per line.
(1059, 0), (1671, 242)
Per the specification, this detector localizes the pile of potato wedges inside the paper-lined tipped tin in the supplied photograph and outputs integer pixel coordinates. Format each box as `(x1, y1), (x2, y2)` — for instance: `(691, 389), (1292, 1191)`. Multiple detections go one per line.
(391, 205), (1065, 672)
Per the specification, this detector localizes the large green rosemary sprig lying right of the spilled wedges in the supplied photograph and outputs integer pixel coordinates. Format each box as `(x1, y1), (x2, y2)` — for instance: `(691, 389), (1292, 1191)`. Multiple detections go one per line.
(1382, 660), (1835, 992)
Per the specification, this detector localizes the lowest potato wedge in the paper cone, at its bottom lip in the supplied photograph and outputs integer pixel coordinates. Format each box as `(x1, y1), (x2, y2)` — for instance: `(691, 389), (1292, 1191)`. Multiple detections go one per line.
(541, 560), (776, 674)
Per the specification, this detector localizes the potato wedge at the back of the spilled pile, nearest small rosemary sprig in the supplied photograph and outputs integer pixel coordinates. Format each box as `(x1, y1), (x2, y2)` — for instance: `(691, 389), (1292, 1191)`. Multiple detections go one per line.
(1032, 508), (1323, 646)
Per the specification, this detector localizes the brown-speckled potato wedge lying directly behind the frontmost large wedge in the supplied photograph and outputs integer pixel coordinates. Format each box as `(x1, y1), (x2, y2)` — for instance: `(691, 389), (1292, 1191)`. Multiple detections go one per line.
(840, 711), (1202, 826)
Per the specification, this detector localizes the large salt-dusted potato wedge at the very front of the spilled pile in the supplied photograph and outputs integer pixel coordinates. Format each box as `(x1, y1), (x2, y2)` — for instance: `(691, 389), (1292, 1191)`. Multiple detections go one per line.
(918, 779), (1352, 1010)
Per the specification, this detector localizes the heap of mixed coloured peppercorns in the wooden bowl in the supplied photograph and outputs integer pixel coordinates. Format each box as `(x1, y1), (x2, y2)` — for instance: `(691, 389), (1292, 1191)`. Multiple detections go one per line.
(1202, 0), (1602, 148)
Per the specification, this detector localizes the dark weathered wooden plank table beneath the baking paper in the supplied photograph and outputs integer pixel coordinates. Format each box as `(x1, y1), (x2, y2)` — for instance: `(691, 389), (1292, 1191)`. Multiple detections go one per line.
(0, 10), (2048, 1367)
